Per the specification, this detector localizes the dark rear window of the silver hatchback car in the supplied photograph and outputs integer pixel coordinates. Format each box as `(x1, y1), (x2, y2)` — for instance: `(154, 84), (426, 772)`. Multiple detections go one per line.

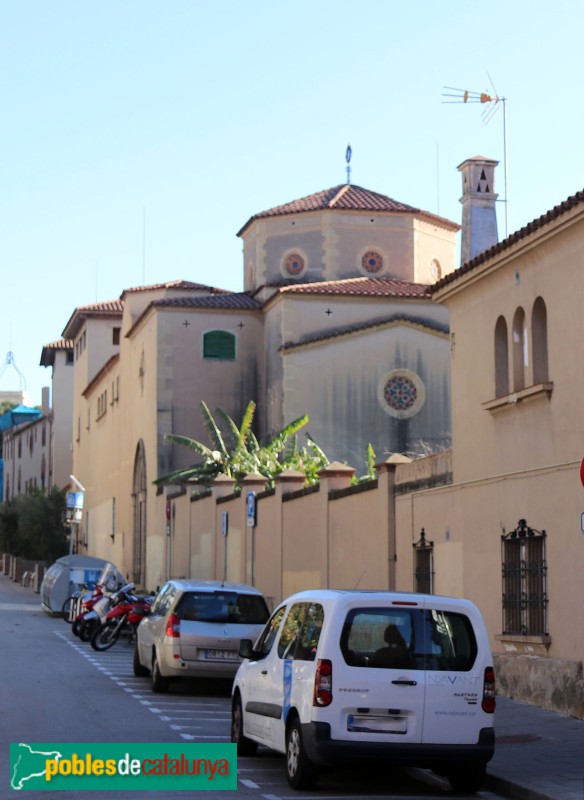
(176, 590), (270, 625)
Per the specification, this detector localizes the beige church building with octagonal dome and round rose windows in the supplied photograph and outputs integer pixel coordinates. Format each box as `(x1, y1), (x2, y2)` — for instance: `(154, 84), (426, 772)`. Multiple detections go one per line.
(52, 175), (460, 584)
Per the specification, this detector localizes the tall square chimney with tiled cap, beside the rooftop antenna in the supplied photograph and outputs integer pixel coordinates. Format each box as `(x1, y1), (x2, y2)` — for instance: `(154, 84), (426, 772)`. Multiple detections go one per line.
(458, 156), (499, 264)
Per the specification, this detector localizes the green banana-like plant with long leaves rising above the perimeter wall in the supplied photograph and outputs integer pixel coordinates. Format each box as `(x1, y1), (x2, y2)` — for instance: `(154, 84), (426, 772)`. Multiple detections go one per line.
(154, 400), (330, 487)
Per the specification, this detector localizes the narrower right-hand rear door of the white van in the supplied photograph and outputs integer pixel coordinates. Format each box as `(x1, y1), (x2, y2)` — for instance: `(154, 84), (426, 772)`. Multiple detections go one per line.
(423, 598), (493, 744)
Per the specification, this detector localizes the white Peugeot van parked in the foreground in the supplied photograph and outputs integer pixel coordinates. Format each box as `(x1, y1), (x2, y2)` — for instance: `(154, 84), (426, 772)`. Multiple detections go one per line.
(231, 589), (495, 792)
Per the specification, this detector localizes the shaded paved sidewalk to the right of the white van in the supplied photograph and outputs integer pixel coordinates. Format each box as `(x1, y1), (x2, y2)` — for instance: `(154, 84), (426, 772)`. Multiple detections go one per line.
(484, 697), (584, 800)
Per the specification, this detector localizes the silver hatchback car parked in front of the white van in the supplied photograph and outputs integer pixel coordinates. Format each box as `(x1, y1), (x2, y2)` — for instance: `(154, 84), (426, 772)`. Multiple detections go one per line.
(134, 580), (270, 692)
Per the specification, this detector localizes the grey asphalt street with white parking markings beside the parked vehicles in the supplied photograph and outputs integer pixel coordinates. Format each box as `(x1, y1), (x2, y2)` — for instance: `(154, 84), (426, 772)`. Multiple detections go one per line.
(0, 575), (500, 800)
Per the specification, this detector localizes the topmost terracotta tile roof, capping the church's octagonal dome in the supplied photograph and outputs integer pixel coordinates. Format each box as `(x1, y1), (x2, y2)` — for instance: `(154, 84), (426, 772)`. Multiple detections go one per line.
(237, 183), (460, 236)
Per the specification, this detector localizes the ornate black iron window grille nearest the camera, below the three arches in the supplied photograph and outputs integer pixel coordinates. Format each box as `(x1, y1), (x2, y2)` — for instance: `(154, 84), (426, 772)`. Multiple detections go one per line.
(501, 519), (548, 636)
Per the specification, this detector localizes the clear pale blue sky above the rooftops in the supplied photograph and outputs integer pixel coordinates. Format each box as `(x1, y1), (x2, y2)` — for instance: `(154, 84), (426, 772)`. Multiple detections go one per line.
(0, 0), (584, 403)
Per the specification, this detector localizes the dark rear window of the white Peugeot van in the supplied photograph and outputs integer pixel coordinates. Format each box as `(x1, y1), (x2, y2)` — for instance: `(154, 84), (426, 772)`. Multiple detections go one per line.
(341, 607), (477, 672)
